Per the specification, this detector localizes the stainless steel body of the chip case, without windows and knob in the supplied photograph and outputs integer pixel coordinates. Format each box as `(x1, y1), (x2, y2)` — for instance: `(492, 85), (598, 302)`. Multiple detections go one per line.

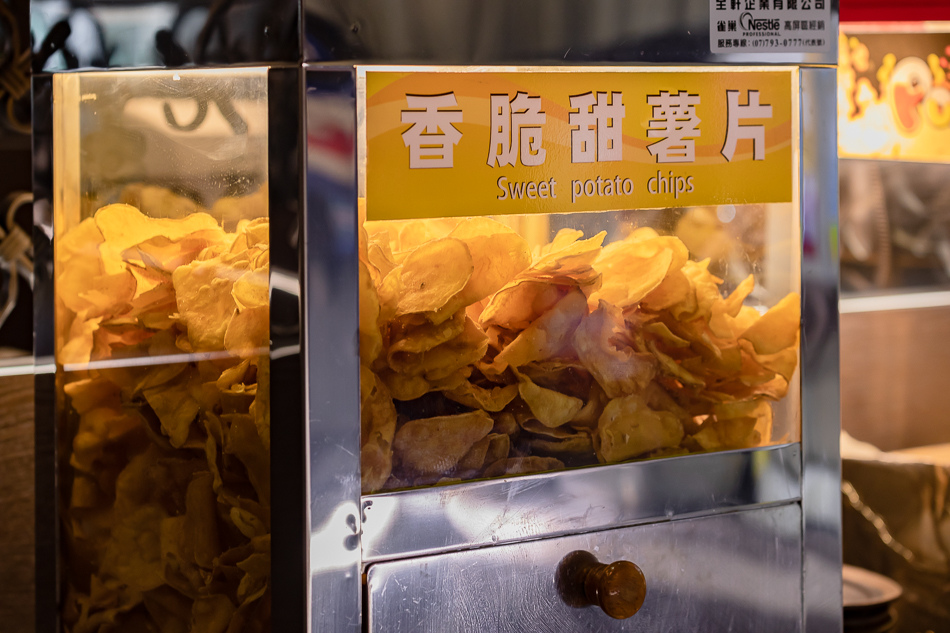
(34, 1), (841, 631)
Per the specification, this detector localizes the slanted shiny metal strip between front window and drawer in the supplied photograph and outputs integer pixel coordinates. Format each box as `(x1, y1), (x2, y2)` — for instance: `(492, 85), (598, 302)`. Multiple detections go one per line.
(362, 444), (801, 562)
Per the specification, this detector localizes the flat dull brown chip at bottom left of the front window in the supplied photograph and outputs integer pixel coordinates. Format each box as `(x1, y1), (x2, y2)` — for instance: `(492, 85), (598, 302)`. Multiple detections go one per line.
(393, 411), (494, 475)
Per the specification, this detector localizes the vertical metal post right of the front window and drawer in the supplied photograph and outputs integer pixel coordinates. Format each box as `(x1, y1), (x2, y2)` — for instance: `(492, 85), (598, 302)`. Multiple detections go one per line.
(801, 68), (843, 633)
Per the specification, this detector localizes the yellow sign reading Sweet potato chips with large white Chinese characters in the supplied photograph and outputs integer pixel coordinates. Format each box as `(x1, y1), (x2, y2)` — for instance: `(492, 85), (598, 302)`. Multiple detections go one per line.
(360, 67), (798, 220)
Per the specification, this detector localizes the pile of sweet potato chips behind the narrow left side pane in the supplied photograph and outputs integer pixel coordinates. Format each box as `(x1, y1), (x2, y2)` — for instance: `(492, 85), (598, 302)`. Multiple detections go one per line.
(55, 199), (271, 633)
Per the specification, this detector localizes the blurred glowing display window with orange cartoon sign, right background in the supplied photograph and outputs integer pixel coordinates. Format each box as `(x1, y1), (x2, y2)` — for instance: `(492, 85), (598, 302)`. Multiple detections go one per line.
(838, 22), (950, 298)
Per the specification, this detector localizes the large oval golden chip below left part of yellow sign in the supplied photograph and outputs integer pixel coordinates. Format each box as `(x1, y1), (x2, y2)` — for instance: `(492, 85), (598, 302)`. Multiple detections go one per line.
(393, 238), (475, 315)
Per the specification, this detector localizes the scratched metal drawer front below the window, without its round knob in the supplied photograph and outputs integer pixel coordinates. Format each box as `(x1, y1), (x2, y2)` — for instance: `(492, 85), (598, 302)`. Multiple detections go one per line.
(367, 504), (802, 633)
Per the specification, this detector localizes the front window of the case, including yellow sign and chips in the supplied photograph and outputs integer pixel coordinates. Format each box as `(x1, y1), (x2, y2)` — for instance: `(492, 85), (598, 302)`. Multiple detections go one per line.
(359, 68), (801, 493)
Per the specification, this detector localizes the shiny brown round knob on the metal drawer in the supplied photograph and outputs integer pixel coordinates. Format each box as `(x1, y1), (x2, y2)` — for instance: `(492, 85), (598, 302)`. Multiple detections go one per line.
(555, 550), (647, 620)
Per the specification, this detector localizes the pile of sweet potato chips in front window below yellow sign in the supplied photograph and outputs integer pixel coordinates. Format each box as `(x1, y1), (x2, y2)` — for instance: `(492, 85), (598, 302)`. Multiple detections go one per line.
(359, 218), (800, 493)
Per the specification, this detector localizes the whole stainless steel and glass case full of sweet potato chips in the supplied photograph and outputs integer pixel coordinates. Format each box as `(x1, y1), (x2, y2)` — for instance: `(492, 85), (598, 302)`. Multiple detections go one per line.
(34, 2), (841, 633)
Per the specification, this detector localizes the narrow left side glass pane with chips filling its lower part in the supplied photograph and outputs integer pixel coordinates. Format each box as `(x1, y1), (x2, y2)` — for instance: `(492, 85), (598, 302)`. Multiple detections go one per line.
(53, 69), (270, 631)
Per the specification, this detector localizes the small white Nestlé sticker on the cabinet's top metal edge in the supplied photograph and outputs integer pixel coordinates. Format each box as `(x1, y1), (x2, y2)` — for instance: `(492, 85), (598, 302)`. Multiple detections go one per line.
(709, 0), (837, 53)
